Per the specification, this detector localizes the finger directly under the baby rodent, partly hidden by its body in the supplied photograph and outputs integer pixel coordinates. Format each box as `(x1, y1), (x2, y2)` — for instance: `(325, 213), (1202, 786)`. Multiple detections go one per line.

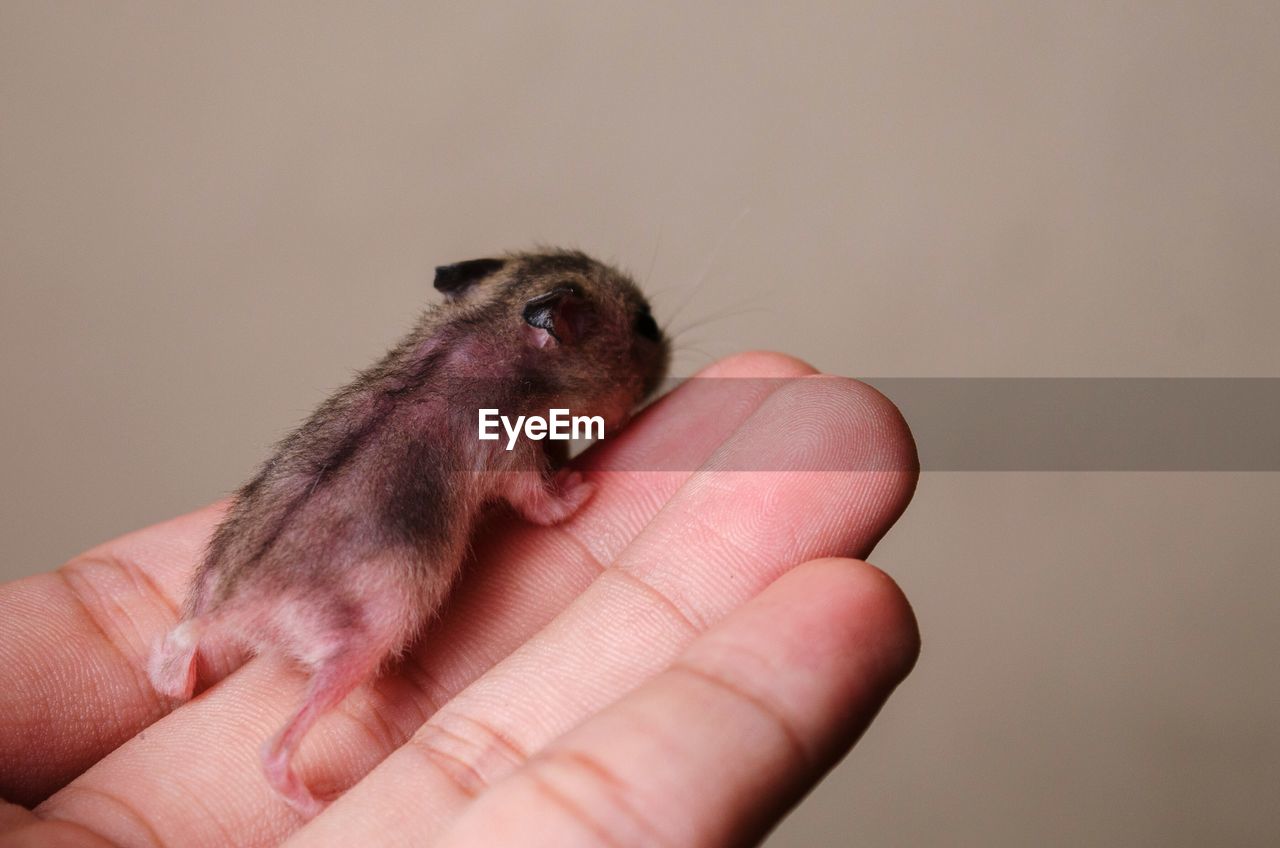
(41, 355), (812, 844)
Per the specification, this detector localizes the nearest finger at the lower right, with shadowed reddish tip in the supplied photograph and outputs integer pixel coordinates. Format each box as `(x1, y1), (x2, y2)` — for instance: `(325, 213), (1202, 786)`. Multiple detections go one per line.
(442, 560), (919, 848)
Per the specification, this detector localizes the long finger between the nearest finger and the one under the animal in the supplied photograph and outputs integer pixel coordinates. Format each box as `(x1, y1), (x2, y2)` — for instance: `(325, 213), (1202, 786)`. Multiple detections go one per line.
(290, 379), (915, 844)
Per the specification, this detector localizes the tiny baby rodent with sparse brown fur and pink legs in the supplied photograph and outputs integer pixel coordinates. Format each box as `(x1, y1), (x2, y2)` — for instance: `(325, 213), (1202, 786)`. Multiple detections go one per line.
(148, 250), (669, 817)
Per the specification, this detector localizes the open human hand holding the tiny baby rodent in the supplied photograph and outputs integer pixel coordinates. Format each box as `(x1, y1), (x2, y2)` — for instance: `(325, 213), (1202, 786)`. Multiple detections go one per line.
(0, 354), (918, 847)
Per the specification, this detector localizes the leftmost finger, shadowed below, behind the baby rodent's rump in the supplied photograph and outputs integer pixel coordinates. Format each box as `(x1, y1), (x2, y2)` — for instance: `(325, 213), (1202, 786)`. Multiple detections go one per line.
(0, 505), (223, 806)
